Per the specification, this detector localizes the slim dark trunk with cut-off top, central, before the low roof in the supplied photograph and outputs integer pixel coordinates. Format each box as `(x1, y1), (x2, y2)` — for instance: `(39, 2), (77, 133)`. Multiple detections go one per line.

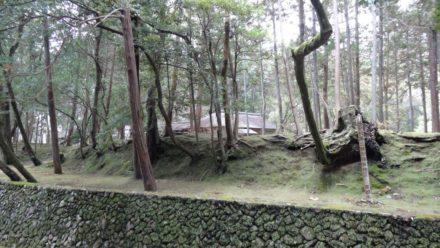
(221, 16), (234, 148)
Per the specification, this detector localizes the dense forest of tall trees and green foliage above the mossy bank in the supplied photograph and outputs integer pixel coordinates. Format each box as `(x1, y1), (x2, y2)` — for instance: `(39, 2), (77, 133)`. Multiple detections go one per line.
(0, 0), (440, 190)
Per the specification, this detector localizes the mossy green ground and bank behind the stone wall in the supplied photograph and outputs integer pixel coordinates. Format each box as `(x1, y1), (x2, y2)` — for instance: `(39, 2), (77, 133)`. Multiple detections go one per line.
(0, 131), (440, 219)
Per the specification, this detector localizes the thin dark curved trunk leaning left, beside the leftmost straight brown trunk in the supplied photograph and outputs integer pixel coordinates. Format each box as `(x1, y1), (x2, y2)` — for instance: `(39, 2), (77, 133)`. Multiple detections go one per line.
(4, 71), (41, 166)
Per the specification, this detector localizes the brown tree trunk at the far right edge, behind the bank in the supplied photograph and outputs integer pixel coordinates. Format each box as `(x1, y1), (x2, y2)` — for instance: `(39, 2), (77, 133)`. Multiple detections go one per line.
(429, 28), (440, 132)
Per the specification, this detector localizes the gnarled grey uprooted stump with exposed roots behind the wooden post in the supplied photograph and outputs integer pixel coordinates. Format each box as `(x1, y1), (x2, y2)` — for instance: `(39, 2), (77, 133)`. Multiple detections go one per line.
(287, 106), (384, 166)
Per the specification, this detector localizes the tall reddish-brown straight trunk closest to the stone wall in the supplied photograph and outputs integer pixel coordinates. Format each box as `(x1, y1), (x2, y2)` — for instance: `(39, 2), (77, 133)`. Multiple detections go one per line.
(121, 8), (157, 191)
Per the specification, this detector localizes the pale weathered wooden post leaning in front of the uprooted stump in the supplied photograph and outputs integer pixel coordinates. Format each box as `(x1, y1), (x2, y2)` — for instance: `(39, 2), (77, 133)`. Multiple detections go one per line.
(356, 114), (371, 202)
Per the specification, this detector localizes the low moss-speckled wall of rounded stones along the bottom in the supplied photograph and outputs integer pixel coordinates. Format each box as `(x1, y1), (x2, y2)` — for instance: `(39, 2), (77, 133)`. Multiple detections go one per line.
(0, 183), (440, 248)
